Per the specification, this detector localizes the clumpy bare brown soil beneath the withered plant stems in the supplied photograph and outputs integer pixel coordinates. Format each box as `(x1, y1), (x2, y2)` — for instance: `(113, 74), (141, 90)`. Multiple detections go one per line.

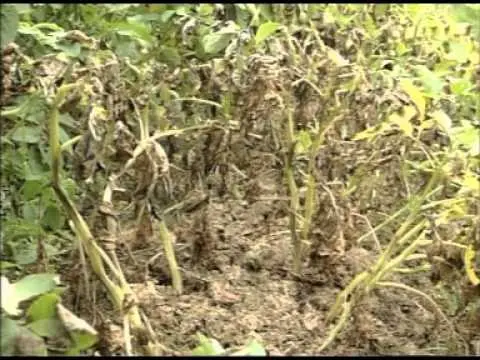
(69, 191), (478, 355)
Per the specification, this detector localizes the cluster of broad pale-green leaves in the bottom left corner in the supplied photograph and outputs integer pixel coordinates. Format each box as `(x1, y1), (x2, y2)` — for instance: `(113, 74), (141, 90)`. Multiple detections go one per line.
(1, 274), (98, 356)
